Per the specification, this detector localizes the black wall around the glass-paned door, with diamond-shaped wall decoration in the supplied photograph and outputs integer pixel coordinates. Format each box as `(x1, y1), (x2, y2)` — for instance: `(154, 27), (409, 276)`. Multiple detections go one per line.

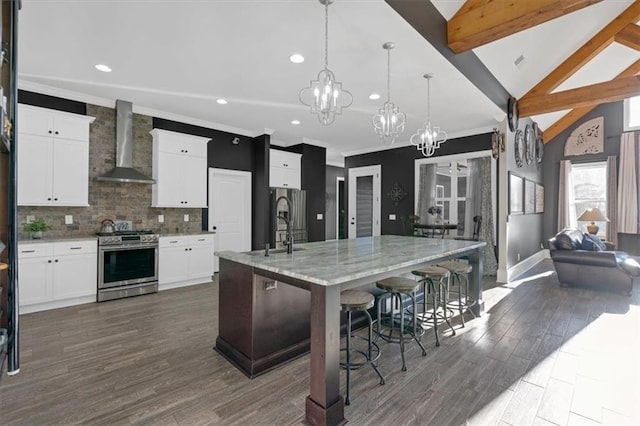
(344, 133), (491, 235)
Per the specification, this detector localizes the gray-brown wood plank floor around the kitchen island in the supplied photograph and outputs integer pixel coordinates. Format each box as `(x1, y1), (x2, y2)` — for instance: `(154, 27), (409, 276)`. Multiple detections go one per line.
(0, 261), (640, 425)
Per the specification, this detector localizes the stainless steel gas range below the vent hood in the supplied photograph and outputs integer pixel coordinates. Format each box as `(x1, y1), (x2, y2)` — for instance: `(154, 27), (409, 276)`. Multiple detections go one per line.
(98, 230), (159, 302)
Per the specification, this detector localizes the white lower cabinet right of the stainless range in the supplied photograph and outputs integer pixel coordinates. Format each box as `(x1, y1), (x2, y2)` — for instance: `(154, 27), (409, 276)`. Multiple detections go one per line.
(158, 234), (214, 290)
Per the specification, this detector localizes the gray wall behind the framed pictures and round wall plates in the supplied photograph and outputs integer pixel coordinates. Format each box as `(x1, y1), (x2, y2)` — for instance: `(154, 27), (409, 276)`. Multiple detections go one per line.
(498, 118), (549, 269)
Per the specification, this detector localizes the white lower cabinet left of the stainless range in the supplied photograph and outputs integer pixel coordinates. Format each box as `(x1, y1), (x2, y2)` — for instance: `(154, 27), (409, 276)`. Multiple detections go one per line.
(18, 240), (98, 313)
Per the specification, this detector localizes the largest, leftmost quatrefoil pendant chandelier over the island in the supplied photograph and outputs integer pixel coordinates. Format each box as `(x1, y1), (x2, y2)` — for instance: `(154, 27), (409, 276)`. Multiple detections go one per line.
(298, 0), (353, 126)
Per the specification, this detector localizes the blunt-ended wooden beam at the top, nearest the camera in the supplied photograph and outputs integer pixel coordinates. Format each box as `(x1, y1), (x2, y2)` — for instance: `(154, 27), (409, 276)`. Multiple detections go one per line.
(447, 0), (602, 53)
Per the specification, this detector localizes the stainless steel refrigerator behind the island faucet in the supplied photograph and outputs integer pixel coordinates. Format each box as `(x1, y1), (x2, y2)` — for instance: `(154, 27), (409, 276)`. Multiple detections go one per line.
(269, 188), (308, 248)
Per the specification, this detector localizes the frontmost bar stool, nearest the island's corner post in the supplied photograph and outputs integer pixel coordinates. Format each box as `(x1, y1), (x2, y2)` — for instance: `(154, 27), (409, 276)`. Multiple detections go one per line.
(340, 290), (384, 405)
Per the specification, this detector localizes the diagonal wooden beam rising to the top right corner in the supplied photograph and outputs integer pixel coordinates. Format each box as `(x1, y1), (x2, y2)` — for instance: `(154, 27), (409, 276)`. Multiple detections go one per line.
(522, 0), (640, 101)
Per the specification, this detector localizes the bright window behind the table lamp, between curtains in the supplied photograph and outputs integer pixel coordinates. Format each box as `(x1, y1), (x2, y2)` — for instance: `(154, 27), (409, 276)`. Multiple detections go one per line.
(571, 161), (607, 237)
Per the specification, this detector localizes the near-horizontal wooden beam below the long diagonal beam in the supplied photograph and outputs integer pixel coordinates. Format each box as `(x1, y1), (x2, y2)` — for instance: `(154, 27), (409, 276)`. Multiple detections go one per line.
(518, 76), (640, 117)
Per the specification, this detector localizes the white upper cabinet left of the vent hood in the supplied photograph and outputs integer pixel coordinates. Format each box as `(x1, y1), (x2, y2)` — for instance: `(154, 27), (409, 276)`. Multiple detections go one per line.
(17, 104), (95, 206)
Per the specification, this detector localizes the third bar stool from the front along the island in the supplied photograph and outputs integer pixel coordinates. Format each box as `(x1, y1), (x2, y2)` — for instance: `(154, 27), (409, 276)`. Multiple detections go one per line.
(411, 265), (456, 346)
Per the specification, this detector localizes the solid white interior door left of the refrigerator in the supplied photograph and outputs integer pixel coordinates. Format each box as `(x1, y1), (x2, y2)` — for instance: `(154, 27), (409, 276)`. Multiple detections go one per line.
(209, 168), (251, 272)
